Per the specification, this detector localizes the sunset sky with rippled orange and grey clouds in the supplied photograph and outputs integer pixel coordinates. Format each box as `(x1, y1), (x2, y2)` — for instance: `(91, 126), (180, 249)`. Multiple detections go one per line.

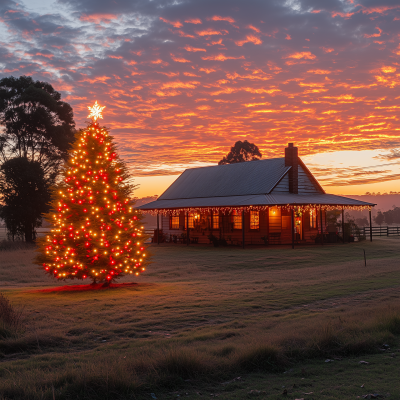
(0, 0), (400, 197)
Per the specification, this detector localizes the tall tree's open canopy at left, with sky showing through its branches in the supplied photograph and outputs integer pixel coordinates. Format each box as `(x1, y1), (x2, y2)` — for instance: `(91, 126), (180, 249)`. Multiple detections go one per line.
(0, 76), (75, 185)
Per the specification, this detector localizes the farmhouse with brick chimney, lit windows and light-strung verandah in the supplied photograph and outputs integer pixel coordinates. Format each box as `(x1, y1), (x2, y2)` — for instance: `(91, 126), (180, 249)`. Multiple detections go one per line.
(138, 143), (375, 246)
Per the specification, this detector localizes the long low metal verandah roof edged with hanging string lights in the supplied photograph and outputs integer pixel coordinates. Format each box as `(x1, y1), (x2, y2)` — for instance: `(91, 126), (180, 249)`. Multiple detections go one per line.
(138, 193), (375, 210)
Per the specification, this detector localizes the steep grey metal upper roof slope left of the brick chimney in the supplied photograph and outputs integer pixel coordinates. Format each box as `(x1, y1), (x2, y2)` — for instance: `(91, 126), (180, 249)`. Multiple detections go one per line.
(157, 158), (290, 201)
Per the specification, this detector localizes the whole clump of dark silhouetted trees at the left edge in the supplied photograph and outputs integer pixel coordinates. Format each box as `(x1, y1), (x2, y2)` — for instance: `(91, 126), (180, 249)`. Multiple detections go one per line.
(0, 76), (75, 242)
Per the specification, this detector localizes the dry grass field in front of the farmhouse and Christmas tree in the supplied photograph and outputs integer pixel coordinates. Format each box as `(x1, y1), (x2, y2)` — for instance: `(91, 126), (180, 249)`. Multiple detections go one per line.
(0, 238), (400, 399)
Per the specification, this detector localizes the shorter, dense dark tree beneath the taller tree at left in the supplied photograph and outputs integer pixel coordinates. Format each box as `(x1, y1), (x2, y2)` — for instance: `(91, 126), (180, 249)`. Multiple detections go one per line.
(0, 157), (50, 242)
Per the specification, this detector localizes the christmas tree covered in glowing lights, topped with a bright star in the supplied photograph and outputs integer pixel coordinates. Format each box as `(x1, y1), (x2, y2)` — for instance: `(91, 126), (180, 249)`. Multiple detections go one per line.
(36, 101), (146, 285)
